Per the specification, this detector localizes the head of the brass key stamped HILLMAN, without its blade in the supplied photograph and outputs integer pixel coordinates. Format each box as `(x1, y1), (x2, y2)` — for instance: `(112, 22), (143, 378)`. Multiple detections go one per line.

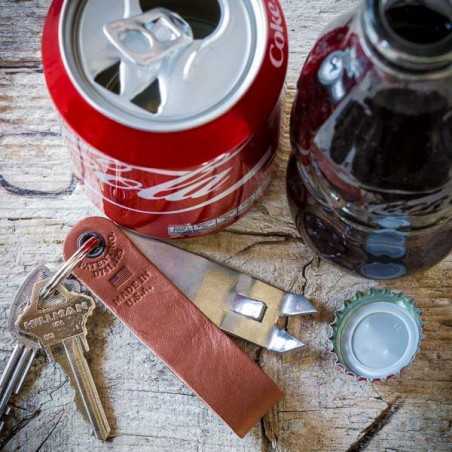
(17, 279), (95, 350)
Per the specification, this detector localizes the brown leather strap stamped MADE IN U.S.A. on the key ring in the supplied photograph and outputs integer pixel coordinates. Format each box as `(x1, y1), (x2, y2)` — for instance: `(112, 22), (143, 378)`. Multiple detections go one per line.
(64, 217), (283, 437)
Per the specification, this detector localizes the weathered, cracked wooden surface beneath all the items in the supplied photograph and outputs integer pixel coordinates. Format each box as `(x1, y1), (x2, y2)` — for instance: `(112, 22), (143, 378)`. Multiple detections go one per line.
(0, 0), (452, 451)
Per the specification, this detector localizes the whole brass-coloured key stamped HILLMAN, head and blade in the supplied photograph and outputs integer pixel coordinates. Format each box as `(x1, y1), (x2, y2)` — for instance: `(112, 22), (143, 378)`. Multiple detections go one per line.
(18, 280), (110, 440)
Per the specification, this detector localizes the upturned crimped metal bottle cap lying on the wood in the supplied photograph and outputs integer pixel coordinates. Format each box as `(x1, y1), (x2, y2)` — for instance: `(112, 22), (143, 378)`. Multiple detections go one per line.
(330, 289), (424, 382)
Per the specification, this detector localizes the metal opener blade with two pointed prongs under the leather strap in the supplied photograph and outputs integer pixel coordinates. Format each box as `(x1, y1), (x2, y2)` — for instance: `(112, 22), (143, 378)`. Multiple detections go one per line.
(125, 231), (316, 353)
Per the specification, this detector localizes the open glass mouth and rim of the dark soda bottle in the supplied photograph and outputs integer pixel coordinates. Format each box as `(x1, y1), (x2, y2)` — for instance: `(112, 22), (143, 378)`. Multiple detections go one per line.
(361, 0), (452, 71)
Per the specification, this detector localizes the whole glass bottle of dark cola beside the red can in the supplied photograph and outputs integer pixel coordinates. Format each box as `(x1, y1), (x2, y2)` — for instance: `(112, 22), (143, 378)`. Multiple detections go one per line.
(287, 0), (452, 279)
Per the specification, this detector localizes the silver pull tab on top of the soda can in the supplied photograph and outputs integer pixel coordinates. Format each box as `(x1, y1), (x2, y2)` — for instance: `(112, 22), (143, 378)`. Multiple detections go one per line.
(104, 8), (194, 66)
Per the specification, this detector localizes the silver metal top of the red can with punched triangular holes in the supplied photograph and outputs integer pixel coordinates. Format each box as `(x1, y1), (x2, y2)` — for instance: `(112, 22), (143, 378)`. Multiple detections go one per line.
(59, 0), (268, 132)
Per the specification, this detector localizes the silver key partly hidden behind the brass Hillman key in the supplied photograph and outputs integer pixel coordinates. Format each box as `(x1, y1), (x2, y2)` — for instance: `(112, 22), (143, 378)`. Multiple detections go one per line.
(0, 266), (80, 432)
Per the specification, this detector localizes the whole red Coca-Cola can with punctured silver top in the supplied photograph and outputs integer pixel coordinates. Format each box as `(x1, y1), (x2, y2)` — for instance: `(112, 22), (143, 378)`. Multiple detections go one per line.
(43, 0), (288, 239)
